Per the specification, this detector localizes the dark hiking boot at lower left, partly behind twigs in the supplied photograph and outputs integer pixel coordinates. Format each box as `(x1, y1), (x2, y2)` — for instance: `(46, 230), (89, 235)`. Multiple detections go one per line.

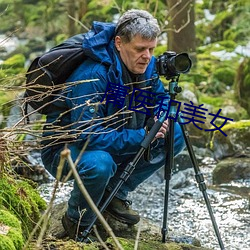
(62, 213), (97, 243)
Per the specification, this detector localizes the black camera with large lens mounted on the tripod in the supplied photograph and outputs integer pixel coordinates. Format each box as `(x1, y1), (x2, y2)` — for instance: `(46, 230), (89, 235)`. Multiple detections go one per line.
(156, 51), (192, 80)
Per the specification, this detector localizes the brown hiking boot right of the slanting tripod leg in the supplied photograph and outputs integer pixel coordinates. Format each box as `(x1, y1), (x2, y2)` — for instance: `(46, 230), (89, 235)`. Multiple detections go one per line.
(105, 197), (140, 225)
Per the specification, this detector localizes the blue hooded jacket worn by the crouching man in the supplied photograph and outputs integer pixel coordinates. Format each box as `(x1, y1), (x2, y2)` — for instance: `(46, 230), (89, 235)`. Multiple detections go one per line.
(45, 22), (170, 155)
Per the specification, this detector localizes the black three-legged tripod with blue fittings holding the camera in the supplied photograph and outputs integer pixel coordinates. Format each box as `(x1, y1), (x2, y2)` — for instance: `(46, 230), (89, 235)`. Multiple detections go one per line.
(82, 78), (225, 250)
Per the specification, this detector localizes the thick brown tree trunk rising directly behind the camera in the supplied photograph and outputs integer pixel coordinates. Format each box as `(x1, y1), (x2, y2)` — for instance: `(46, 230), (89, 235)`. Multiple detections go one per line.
(167, 0), (196, 61)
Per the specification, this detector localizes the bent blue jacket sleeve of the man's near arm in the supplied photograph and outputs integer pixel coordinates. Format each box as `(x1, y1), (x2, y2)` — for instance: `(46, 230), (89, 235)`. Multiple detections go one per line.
(66, 62), (146, 155)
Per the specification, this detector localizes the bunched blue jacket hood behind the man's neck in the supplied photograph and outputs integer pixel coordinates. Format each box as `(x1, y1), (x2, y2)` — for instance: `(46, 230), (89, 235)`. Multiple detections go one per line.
(82, 21), (116, 65)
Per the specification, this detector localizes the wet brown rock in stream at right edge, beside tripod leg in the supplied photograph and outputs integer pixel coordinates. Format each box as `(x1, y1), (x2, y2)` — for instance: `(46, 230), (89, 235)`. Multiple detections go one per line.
(213, 157), (250, 184)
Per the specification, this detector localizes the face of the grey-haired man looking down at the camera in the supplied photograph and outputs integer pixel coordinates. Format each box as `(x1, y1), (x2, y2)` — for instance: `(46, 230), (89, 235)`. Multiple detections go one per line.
(115, 35), (157, 74)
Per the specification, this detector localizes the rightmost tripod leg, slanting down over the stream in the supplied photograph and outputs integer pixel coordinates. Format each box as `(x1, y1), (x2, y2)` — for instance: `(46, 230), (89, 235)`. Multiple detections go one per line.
(180, 121), (225, 250)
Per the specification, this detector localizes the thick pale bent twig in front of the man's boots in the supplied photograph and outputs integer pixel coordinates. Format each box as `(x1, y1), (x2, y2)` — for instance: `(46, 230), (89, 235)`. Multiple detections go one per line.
(61, 149), (124, 250)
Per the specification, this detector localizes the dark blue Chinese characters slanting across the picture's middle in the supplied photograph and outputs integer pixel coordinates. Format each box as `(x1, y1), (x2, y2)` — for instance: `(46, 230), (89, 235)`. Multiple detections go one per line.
(102, 83), (233, 136)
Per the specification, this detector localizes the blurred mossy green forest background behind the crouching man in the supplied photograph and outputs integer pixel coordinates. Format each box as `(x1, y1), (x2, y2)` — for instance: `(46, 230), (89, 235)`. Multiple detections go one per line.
(0, 0), (250, 124)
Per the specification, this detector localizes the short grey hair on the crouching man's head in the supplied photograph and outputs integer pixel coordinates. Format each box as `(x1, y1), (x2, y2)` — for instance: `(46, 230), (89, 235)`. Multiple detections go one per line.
(116, 9), (160, 43)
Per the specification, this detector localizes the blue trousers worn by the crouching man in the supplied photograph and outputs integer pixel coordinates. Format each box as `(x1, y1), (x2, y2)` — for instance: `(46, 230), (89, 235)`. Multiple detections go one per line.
(42, 123), (185, 226)
